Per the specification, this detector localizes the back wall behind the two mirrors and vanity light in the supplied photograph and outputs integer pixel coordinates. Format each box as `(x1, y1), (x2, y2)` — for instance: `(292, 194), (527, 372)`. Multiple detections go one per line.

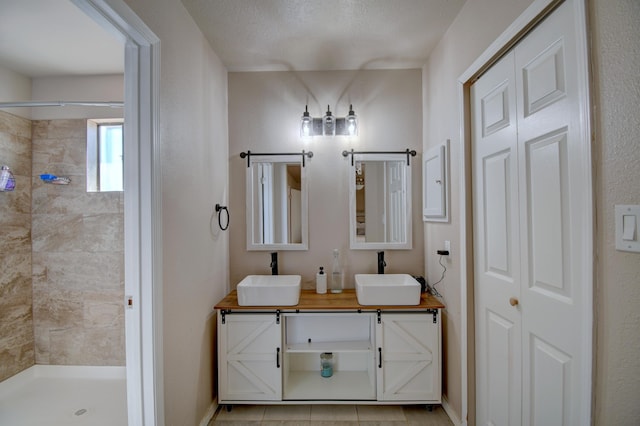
(229, 69), (423, 288)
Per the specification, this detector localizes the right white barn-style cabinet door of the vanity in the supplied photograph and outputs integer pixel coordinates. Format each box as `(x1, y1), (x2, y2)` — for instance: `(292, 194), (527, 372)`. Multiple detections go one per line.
(376, 310), (441, 403)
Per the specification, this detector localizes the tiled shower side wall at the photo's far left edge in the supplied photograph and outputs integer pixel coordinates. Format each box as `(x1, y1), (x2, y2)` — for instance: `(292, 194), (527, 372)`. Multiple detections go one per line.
(0, 111), (34, 381)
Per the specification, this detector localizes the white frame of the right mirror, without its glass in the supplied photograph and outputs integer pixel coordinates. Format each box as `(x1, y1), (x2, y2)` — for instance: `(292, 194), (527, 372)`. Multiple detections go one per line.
(347, 153), (413, 250)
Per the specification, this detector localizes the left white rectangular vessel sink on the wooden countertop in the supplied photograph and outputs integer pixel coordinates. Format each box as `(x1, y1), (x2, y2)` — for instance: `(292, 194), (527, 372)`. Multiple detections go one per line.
(236, 275), (300, 306)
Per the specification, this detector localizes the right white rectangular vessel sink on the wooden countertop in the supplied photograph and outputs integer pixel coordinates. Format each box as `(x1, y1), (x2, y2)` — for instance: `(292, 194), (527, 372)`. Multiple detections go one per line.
(356, 274), (420, 306)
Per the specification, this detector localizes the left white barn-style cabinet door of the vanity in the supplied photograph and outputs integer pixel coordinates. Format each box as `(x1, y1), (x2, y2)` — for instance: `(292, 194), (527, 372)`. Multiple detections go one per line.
(218, 311), (282, 402)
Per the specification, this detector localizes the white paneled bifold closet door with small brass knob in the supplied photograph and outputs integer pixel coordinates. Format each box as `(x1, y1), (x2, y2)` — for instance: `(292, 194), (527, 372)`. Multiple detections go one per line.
(472, 1), (591, 426)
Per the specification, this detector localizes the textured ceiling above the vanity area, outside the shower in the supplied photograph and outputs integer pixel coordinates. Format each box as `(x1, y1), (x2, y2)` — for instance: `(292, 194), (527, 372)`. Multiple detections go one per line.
(182, 0), (464, 71)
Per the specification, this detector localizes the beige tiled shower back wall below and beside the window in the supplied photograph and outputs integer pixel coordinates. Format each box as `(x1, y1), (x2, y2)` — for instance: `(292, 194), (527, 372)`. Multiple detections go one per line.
(31, 120), (125, 365)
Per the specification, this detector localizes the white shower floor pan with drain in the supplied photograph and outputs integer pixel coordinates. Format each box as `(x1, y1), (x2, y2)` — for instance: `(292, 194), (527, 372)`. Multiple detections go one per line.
(0, 365), (127, 426)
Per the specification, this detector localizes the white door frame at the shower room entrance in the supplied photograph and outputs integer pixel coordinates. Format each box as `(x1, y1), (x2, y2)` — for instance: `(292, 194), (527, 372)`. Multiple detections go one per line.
(72, 0), (164, 426)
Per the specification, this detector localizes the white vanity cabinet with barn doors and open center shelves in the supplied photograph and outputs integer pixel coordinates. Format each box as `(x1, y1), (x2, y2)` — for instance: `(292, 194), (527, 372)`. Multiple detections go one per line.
(218, 302), (441, 404)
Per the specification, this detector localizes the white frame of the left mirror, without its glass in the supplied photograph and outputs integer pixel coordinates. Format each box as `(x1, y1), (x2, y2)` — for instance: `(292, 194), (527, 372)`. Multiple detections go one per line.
(245, 154), (309, 251)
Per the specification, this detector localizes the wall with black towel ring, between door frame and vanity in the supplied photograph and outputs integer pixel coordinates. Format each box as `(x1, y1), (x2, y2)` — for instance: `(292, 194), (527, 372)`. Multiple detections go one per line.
(121, 0), (228, 426)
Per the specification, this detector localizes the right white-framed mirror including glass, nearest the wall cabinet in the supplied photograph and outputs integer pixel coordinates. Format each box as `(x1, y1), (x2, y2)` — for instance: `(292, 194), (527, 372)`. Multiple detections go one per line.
(348, 153), (412, 250)
